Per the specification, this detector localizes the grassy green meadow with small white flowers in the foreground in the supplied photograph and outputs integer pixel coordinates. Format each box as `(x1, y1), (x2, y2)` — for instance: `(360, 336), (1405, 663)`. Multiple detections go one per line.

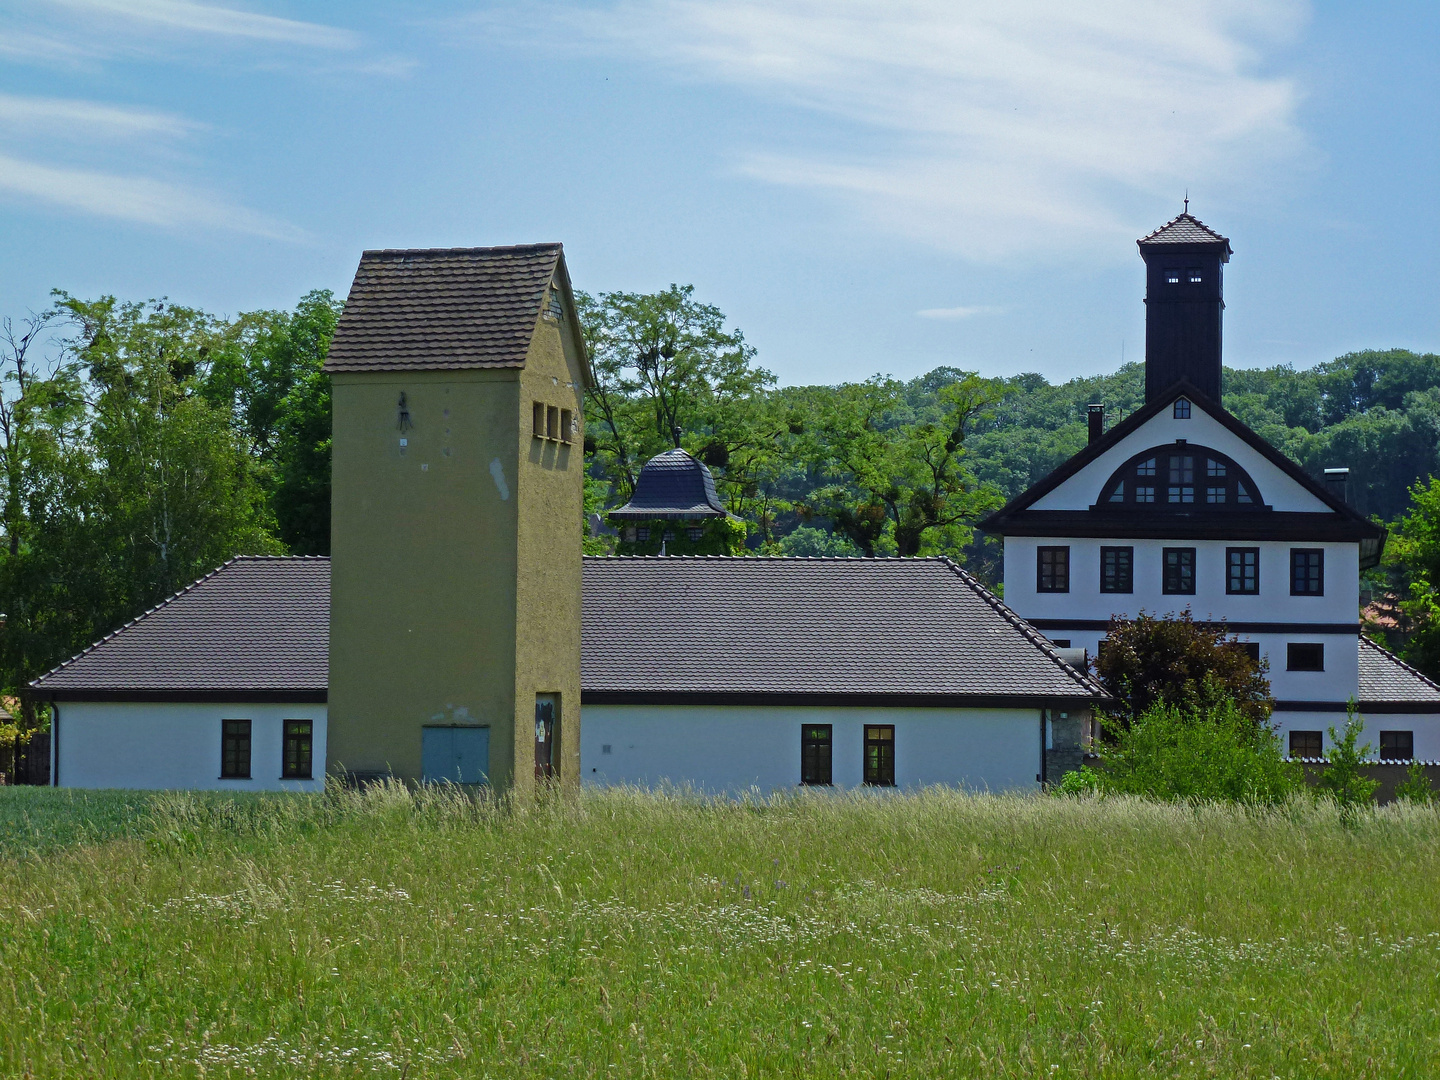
(0, 788), (1440, 1077)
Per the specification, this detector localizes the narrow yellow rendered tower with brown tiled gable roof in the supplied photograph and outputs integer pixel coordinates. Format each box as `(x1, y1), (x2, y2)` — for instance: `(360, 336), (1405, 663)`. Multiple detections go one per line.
(325, 243), (589, 789)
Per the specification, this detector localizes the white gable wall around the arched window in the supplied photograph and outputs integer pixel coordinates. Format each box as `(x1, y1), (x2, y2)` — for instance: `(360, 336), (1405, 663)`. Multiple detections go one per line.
(1028, 406), (1335, 513)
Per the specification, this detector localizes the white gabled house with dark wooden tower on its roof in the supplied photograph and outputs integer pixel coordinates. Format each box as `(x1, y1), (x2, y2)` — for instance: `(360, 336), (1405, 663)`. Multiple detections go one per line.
(982, 213), (1440, 760)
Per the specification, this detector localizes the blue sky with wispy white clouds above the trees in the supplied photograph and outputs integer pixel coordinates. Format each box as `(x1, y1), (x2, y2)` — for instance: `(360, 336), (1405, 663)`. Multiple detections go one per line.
(0, 0), (1440, 384)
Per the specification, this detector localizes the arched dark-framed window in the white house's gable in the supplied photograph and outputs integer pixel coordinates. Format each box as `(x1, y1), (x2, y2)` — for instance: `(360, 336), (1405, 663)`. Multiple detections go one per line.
(1096, 442), (1263, 511)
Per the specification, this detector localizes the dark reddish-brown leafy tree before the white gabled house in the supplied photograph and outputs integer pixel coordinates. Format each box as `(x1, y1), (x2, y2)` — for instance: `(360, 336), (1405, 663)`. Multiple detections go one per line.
(1096, 608), (1274, 724)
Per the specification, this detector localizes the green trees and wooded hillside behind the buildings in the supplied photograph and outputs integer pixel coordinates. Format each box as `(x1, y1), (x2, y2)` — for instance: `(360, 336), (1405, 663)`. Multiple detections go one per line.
(0, 285), (1440, 728)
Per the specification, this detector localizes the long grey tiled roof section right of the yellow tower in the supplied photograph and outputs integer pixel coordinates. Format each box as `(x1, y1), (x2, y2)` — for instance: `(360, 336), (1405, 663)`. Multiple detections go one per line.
(582, 556), (1104, 702)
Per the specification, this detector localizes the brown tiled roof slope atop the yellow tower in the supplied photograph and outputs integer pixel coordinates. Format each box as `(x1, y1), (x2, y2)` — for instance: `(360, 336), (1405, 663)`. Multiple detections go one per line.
(325, 243), (569, 372)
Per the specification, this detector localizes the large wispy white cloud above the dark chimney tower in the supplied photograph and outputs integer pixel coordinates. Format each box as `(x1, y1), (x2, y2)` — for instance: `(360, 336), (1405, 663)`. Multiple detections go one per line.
(544, 0), (1308, 259)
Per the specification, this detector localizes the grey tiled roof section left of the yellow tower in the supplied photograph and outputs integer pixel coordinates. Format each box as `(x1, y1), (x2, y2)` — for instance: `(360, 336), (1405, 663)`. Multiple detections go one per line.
(30, 556), (330, 701)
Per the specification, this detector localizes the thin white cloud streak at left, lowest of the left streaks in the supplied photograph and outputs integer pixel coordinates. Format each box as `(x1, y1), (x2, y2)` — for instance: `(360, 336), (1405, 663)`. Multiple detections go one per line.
(0, 156), (304, 242)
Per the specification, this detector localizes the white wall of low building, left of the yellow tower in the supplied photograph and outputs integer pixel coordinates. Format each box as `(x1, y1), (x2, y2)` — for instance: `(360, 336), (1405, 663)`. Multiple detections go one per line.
(55, 701), (325, 791)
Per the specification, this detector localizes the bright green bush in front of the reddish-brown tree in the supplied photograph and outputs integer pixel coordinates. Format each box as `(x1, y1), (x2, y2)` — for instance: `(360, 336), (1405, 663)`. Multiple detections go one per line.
(1060, 703), (1305, 805)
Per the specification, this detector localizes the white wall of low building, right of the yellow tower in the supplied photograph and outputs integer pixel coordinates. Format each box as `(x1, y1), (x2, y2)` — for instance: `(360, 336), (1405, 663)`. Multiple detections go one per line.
(580, 706), (1041, 793)
